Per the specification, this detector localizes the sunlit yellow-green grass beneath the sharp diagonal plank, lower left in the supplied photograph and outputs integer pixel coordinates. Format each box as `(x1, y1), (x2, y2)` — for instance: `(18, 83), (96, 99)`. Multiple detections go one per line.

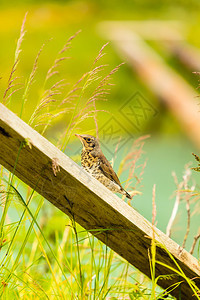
(0, 176), (156, 299)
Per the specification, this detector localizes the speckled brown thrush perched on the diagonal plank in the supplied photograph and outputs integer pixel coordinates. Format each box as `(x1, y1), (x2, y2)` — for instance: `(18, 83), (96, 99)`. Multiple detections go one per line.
(75, 134), (131, 199)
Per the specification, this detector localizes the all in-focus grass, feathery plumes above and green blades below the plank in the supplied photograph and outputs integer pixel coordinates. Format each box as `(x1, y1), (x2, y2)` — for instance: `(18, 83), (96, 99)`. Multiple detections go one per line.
(0, 12), (199, 300)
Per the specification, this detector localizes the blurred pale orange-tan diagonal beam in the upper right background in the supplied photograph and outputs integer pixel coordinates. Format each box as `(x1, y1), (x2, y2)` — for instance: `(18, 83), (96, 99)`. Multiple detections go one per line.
(99, 21), (200, 148)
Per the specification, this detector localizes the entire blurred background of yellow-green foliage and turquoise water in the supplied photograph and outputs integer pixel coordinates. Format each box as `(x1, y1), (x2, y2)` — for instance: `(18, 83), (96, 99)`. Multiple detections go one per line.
(0, 0), (200, 254)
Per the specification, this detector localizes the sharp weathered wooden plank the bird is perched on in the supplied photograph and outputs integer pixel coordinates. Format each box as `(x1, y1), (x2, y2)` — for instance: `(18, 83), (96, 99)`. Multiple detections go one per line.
(0, 104), (200, 300)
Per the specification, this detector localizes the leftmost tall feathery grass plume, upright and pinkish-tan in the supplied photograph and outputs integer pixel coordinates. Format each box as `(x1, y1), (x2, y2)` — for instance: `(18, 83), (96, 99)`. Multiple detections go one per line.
(2, 13), (27, 106)
